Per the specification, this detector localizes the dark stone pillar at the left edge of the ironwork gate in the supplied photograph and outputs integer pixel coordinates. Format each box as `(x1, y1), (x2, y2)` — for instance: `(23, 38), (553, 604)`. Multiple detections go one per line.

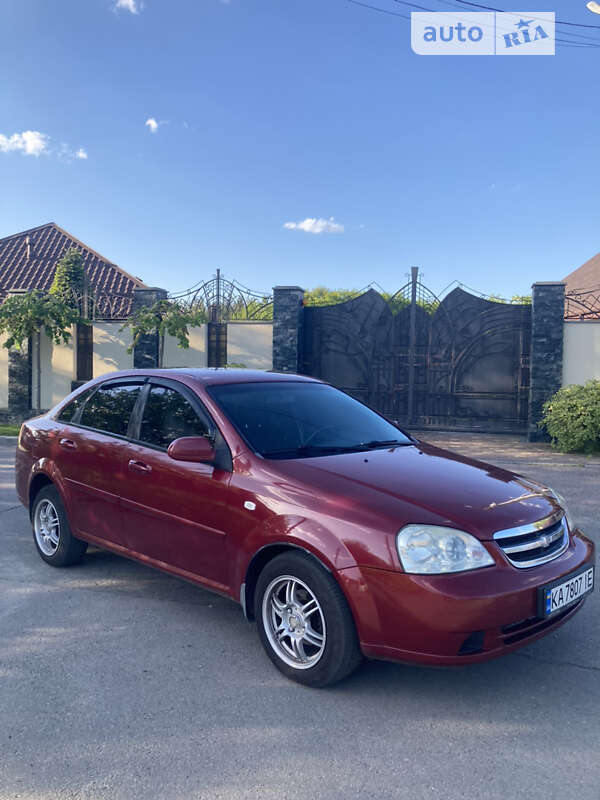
(273, 286), (304, 372)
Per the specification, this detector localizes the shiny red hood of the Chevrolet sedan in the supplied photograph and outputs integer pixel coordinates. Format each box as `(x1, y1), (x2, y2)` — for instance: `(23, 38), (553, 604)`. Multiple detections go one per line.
(277, 442), (560, 539)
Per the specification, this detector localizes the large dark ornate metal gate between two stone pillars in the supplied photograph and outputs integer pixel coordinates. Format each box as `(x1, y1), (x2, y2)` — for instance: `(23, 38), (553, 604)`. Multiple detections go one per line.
(303, 268), (531, 432)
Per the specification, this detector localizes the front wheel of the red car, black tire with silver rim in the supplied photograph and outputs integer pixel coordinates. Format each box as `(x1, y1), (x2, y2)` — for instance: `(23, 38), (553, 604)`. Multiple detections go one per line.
(254, 552), (362, 688)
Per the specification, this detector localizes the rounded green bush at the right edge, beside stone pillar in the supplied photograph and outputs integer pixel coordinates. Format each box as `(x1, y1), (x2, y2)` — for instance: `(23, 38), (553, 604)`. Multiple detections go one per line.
(540, 381), (600, 453)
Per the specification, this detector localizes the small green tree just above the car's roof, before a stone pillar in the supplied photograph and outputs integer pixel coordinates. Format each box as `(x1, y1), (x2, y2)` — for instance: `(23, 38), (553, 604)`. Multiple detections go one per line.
(121, 300), (208, 366)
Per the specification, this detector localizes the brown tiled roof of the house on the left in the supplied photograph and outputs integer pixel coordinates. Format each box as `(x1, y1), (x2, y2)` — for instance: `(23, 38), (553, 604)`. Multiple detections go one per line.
(0, 222), (145, 319)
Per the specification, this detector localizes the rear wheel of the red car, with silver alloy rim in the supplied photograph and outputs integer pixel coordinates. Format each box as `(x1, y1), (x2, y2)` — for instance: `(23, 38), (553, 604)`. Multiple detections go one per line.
(31, 485), (87, 567)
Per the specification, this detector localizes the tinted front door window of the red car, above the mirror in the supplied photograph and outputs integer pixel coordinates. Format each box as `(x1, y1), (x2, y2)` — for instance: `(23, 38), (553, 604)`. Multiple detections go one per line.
(140, 386), (210, 449)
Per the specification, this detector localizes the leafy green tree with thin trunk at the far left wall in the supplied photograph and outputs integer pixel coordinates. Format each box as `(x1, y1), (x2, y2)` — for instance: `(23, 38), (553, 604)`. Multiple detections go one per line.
(0, 290), (80, 409)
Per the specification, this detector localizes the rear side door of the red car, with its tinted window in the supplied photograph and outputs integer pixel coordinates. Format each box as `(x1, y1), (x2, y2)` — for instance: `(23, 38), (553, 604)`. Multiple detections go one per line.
(54, 379), (143, 545)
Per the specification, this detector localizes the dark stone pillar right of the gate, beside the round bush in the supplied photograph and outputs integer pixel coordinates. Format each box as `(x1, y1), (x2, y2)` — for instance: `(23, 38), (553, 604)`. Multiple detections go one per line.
(527, 281), (565, 442)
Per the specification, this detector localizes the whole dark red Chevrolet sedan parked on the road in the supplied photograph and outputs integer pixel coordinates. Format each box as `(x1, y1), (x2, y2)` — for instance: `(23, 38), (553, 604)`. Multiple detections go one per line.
(16, 369), (594, 686)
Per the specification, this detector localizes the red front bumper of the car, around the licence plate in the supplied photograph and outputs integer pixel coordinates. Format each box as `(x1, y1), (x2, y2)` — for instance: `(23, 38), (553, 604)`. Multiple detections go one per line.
(337, 531), (594, 666)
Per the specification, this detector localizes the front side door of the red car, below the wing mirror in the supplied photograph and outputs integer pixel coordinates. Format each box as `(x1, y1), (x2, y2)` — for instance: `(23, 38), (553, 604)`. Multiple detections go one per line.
(121, 379), (231, 588)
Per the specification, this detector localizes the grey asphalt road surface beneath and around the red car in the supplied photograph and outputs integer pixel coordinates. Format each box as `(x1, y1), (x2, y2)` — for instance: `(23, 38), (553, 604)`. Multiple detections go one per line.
(0, 436), (600, 800)
